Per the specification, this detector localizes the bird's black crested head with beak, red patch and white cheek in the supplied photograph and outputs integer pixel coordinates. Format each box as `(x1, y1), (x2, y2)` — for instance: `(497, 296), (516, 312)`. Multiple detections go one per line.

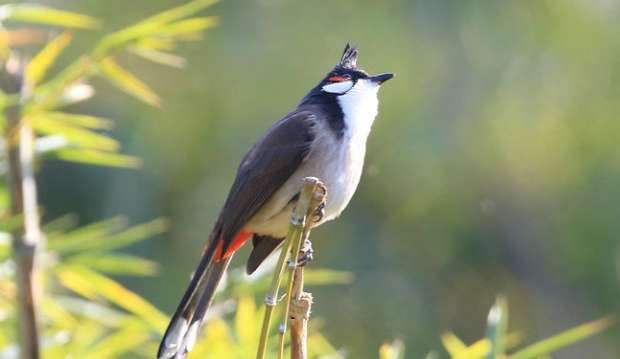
(302, 43), (394, 103)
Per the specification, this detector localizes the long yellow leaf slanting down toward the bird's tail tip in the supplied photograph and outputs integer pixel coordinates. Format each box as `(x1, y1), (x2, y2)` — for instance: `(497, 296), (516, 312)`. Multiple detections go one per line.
(59, 264), (168, 332)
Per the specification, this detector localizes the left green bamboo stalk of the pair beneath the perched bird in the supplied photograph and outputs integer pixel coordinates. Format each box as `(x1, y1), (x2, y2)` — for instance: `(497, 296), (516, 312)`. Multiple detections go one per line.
(256, 177), (324, 359)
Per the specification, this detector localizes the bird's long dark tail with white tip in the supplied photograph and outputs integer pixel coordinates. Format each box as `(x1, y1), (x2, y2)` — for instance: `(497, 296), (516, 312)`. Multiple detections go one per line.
(157, 236), (232, 359)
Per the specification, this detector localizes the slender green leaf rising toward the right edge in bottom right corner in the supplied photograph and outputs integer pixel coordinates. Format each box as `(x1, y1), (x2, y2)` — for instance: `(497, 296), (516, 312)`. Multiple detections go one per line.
(509, 316), (614, 359)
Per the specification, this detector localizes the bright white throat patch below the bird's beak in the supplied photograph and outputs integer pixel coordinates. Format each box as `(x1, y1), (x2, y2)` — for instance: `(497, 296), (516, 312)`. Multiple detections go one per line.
(338, 79), (379, 146)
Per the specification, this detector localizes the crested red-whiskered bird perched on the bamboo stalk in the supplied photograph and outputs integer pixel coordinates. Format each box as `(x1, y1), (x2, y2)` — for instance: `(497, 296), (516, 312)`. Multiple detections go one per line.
(157, 43), (394, 359)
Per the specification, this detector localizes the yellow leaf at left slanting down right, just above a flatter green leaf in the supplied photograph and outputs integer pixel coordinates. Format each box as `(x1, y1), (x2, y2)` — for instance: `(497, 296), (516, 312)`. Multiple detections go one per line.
(28, 113), (120, 151)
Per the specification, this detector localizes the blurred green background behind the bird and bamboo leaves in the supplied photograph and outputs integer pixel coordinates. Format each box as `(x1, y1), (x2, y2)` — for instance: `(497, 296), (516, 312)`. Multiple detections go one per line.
(39, 0), (620, 358)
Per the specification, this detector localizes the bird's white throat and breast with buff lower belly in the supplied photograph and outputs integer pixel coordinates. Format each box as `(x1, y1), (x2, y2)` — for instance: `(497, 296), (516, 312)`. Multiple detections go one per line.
(244, 80), (378, 237)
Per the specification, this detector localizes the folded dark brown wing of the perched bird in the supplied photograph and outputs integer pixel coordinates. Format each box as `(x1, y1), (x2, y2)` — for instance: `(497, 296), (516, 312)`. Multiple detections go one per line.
(212, 111), (316, 253)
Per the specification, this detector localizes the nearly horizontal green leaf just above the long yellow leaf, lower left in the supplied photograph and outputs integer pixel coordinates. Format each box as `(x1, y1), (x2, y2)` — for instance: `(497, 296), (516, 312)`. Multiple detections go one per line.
(66, 252), (157, 276)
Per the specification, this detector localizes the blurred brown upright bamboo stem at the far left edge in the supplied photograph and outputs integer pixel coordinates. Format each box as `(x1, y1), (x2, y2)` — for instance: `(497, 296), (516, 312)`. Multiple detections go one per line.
(1, 59), (42, 359)
